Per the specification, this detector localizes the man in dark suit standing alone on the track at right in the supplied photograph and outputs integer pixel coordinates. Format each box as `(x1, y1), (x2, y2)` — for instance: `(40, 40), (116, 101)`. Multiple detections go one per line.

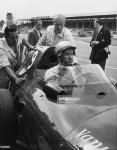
(89, 19), (111, 70)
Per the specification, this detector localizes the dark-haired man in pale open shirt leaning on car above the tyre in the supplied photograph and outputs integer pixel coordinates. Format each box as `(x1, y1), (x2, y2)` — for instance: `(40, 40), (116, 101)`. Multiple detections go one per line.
(0, 24), (27, 88)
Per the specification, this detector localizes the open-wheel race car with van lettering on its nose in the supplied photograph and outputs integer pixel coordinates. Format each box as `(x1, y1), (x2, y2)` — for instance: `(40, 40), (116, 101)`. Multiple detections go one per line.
(0, 46), (117, 150)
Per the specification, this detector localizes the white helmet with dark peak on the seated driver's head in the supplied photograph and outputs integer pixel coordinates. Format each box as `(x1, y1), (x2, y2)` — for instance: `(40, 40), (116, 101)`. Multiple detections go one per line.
(55, 41), (76, 57)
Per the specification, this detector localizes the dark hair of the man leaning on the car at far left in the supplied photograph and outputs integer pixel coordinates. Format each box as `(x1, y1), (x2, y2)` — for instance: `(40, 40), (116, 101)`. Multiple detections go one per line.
(4, 24), (18, 37)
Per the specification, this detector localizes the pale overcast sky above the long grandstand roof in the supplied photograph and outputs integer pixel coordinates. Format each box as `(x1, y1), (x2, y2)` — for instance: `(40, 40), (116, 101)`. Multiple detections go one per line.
(0, 0), (117, 20)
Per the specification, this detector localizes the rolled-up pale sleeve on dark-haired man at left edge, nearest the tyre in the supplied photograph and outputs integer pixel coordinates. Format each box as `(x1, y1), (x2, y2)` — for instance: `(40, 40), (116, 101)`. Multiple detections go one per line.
(0, 49), (10, 69)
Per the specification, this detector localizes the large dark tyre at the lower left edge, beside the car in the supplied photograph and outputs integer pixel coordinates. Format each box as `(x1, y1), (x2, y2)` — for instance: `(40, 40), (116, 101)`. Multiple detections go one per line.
(0, 89), (18, 145)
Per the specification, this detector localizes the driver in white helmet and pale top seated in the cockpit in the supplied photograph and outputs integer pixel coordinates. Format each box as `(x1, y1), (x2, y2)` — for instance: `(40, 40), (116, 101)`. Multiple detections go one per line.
(44, 41), (78, 85)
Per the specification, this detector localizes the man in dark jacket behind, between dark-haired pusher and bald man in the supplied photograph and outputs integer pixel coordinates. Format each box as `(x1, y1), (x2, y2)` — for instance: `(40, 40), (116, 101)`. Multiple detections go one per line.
(28, 20), (42, 46)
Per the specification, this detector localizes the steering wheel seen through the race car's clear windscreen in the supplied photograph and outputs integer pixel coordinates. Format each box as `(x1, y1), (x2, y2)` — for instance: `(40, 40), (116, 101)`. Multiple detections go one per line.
(71, 72), (98, 85)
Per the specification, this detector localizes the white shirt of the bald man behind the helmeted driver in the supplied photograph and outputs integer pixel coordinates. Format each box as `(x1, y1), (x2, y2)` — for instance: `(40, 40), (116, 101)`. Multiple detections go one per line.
(37, 25), (75, 46)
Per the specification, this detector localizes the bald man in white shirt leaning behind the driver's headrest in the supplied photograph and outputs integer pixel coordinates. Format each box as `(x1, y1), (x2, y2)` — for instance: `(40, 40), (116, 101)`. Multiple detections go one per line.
(37, 14), (75, 46)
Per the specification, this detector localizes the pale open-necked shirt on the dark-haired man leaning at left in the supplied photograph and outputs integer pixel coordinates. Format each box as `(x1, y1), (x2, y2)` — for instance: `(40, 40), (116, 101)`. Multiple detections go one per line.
(0, 38), (22, 88)
